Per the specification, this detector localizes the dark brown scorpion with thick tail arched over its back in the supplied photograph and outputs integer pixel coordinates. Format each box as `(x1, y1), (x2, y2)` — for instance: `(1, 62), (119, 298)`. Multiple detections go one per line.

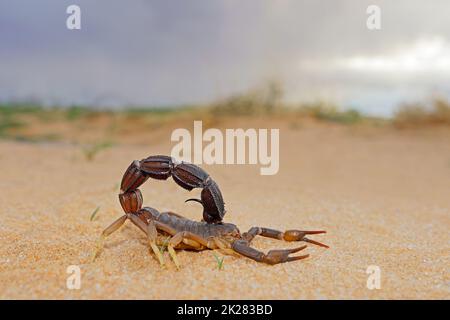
(94, 155), (328, 269)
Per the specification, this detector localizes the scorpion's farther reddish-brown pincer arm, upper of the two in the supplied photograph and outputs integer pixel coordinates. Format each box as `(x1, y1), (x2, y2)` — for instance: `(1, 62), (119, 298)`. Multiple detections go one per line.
(242, 227), (329, 248)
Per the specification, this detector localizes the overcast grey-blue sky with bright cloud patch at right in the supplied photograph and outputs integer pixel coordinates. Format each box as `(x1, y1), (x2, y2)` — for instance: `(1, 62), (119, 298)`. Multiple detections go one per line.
(0, 0), (450, 115)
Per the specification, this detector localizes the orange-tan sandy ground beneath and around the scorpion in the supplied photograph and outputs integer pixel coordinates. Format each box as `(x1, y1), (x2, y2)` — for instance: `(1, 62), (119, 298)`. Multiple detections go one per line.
(0, 122), (450, 299)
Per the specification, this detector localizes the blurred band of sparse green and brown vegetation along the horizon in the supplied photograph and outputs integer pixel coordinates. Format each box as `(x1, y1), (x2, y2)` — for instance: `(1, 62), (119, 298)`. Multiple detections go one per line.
(0, 91), (450, 145)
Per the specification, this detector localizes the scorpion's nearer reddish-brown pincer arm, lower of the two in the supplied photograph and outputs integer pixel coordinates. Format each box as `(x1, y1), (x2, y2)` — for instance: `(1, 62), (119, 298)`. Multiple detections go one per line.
(232, 240), (309, 264)
